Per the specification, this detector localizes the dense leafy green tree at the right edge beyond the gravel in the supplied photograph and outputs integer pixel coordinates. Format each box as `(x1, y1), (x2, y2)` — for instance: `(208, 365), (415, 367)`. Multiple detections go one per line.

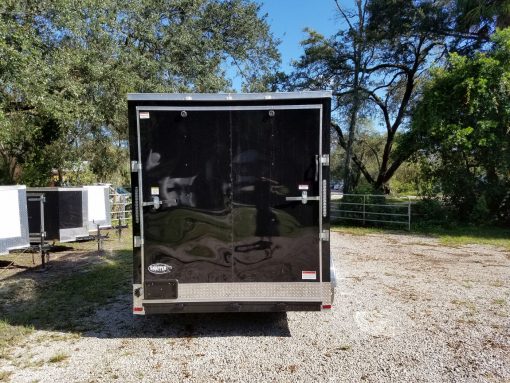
(411, 29), (510, 220)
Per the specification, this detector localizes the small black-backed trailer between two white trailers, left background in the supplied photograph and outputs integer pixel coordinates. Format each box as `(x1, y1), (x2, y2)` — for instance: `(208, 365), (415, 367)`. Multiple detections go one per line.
(27, 187), (89, 242)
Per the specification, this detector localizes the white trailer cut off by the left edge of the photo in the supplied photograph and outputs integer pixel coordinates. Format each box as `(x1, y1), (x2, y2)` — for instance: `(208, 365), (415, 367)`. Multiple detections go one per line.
(0, 185), (30, 255)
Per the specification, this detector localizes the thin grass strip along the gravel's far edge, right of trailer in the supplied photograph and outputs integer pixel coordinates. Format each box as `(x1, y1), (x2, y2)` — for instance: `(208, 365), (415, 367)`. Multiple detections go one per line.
(331, 225), (510, 251)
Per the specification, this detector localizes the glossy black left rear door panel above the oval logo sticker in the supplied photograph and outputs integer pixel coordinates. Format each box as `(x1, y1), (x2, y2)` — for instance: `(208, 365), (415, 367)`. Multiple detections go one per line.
(140, 111), (232, 283)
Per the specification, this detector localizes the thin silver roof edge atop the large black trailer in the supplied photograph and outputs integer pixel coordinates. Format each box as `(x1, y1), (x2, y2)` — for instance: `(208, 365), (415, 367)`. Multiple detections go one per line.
(128, 90), (333, 101)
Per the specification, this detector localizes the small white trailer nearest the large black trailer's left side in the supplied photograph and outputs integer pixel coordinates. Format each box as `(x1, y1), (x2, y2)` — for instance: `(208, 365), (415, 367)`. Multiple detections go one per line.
(83, 185), (112, 231)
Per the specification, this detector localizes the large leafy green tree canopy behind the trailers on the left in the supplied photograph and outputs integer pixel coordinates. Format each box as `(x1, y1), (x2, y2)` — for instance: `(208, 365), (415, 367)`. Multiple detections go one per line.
(0, 0), (279, 185)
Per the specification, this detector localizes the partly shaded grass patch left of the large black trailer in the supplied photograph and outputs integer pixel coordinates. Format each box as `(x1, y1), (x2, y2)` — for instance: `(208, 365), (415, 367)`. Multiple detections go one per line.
(0, 233), (132, 364)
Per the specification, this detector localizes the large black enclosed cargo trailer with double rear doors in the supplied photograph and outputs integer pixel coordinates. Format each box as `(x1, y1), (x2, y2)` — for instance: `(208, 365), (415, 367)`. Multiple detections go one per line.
(128, 92), (334, 314)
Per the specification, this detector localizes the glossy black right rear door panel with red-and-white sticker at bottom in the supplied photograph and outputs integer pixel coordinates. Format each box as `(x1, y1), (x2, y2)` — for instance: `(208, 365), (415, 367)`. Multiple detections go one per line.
(232, 108), (320, 282)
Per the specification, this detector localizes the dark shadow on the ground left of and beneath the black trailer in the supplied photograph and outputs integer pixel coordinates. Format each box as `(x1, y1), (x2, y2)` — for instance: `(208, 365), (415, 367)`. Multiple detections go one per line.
(0, 250), (290, 338)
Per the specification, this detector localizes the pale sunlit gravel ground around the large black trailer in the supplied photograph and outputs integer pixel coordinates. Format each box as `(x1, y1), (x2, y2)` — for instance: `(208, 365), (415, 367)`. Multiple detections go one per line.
(0, 234), (510, 383)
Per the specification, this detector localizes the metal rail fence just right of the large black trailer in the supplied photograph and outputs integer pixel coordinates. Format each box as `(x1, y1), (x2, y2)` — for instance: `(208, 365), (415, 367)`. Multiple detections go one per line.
(331, 194), (411, 230)
